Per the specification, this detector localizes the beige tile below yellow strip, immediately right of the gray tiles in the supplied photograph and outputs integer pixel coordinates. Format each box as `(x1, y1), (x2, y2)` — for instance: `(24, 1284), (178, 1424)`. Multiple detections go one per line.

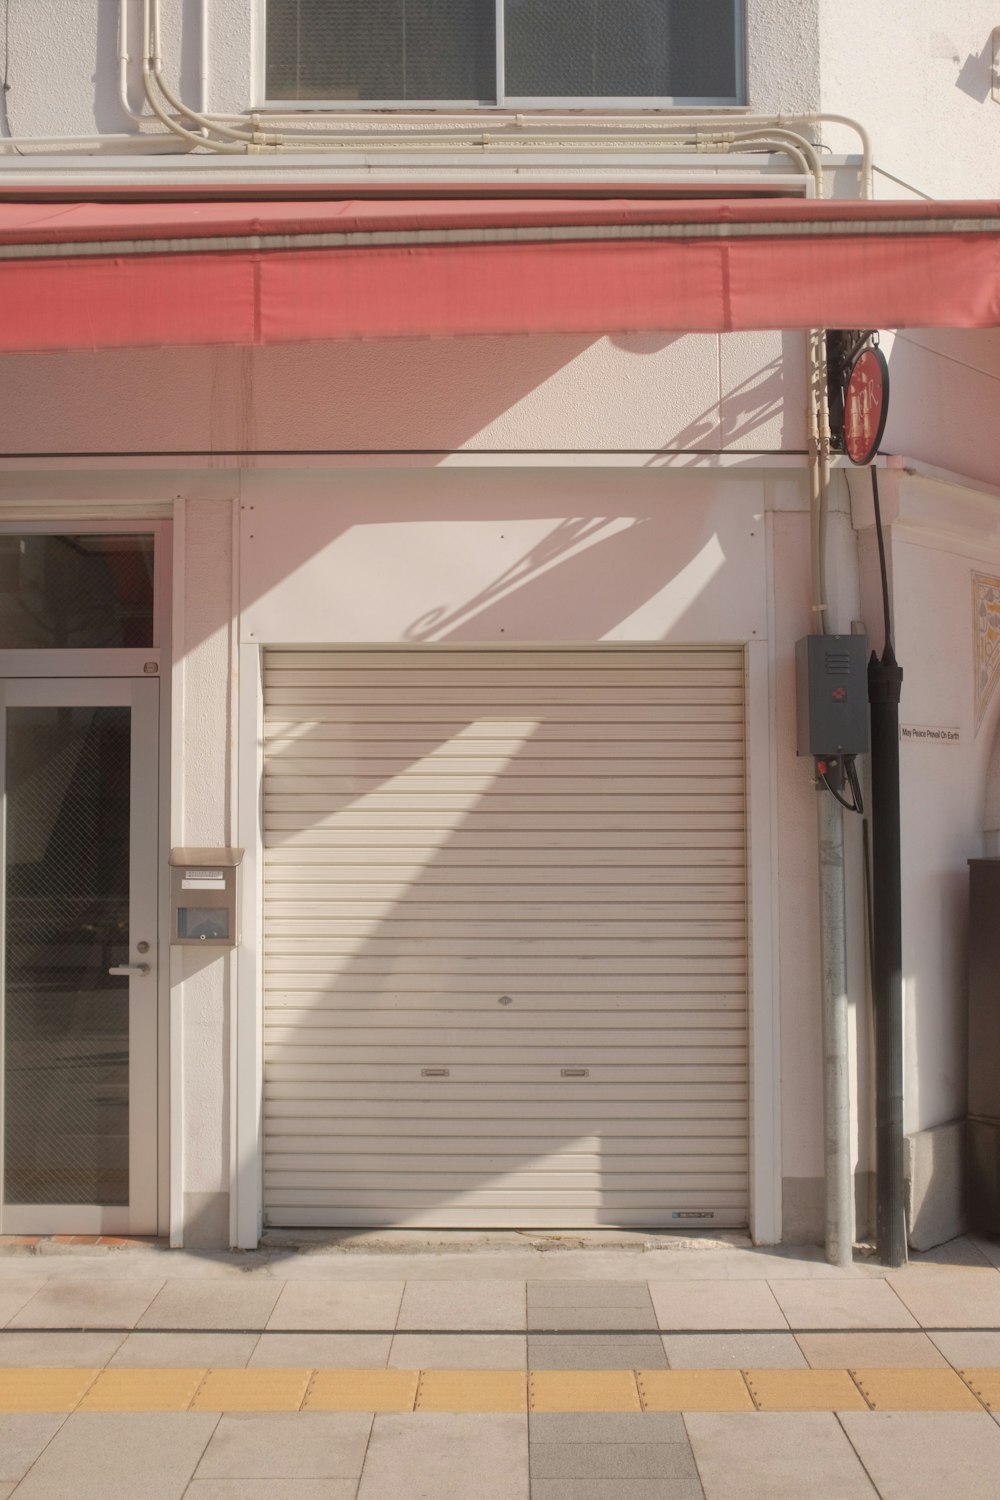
(684, 1412), (881, 1500)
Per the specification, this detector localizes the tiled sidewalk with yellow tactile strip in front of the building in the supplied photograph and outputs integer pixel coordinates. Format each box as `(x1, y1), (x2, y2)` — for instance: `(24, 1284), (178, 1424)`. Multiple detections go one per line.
(0, 1241), (1000, 1500)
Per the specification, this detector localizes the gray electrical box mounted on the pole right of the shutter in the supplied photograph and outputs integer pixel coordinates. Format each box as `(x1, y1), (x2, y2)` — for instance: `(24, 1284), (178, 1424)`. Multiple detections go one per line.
(795, 636), (868, 756)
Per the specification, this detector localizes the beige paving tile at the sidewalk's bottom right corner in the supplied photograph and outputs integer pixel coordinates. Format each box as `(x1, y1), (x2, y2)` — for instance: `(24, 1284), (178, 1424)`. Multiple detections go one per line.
(841, 1412), (1000, 1500)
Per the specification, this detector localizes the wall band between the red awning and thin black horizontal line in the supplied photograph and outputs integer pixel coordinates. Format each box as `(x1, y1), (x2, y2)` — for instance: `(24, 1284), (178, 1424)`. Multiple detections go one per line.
(0, 333), (805, 453)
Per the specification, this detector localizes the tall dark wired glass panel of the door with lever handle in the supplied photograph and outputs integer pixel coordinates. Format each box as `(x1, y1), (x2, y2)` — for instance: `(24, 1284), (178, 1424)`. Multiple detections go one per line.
(4, 708), (130, 1205)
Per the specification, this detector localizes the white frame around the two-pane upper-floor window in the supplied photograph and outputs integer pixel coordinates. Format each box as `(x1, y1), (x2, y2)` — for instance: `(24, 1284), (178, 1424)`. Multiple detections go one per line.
(252, 0), (747, 114)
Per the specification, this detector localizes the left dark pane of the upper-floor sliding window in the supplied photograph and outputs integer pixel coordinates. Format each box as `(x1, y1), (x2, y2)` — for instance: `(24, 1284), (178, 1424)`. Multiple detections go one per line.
(265, 0), (496, 102)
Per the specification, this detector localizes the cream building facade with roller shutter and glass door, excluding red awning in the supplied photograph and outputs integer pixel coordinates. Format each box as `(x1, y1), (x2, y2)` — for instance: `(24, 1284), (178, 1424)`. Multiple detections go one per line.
(0, 0), (1000, 1247)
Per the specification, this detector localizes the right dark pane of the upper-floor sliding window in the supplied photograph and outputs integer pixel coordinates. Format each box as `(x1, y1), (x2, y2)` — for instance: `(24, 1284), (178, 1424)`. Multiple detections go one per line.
(505, 0), (736, 99)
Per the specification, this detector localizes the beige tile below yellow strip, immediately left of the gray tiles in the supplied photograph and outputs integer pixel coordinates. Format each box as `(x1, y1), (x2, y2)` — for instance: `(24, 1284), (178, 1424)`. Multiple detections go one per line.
(358, 1412), (528, 1500)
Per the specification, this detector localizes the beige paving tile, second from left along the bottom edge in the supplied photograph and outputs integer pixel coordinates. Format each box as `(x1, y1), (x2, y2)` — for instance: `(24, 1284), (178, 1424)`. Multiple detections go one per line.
(8, 1412), (216, 1500)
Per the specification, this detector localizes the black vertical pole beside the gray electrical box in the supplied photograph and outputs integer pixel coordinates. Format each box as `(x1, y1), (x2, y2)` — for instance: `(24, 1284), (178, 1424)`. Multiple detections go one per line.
(868, 468), (906, 1266)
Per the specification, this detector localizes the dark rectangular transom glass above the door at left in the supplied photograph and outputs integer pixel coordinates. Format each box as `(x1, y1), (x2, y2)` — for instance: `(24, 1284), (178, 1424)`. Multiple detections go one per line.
(0, 534), (153, 651)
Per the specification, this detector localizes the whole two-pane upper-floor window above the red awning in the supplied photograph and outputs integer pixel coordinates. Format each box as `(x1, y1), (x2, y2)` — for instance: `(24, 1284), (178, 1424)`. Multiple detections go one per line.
(265, 0), (742, 108)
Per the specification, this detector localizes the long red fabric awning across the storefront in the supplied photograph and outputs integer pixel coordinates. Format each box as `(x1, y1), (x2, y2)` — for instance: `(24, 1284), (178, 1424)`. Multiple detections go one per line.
(0, 197), (1000, 351)
